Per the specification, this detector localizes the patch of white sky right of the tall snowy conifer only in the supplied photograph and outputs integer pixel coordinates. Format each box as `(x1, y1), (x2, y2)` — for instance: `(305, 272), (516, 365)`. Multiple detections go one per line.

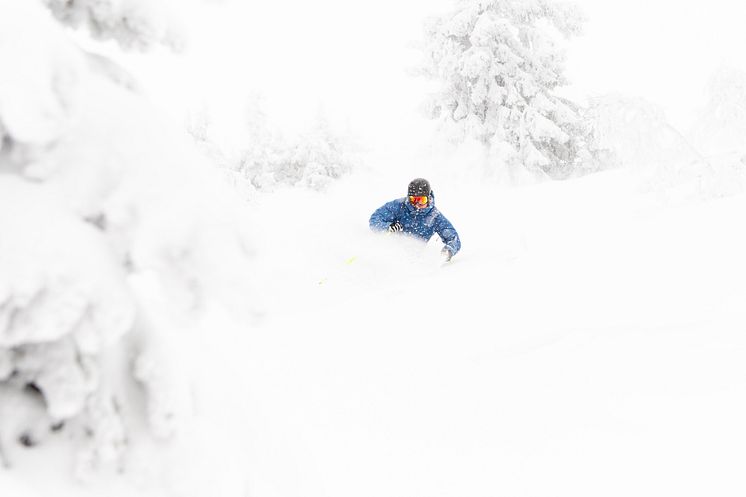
(567, 0), (746, 127)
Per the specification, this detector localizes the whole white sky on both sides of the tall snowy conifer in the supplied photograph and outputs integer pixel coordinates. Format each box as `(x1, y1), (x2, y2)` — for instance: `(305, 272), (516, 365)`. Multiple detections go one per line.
(122, 0), (746, 146)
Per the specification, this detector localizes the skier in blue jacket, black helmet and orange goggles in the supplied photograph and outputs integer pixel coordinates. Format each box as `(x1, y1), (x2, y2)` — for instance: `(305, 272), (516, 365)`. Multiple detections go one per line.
(369, 178), (461, 262)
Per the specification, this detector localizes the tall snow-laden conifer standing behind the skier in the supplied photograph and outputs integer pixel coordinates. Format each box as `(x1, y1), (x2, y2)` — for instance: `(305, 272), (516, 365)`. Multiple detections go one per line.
(421, 0), (589, 177)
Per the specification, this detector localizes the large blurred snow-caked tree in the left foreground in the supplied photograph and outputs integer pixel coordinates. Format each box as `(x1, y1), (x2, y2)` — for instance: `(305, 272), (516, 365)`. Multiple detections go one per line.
(0, 0), (251, 488)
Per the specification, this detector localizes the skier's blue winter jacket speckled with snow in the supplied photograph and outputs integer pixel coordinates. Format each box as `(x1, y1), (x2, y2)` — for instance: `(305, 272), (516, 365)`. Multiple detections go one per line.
(369, 192), (461, 255)
